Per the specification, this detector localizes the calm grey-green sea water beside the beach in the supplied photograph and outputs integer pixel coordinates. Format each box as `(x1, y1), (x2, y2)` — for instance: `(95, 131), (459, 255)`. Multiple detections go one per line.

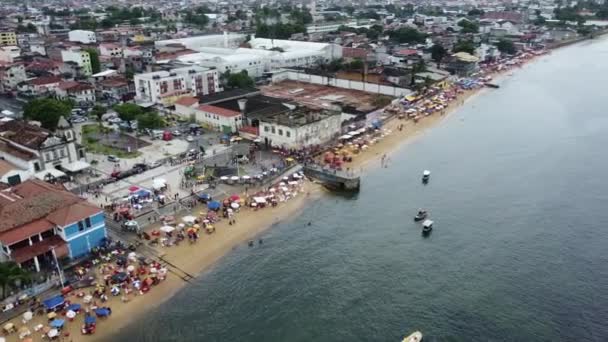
(113, 40), (608, 342)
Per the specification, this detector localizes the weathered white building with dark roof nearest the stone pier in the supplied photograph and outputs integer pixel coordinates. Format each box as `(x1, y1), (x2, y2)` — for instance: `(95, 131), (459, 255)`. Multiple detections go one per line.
(259, 108), (342, 148)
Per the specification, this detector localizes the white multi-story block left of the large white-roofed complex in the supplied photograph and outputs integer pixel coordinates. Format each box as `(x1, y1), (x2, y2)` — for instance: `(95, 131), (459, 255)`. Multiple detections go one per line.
(135, 65), (222, 105)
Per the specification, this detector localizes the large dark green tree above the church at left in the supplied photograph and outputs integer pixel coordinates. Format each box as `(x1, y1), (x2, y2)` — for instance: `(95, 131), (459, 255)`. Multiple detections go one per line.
(23, 98), (73, 131)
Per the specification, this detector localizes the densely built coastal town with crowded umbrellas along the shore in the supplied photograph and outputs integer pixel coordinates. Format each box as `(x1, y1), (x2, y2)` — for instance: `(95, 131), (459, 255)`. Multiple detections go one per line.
(0, 0), (608, 336)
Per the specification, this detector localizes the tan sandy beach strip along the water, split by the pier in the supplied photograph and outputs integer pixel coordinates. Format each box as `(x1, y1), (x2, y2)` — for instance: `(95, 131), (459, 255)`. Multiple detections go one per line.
(0, 52), (540, 341)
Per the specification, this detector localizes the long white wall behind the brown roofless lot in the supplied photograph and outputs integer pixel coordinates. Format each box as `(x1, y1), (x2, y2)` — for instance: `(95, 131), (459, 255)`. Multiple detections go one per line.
(272, 70), (413, 97)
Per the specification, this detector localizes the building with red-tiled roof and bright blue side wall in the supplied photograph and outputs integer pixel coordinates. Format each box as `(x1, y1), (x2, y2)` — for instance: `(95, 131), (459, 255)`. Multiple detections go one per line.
(0, 180), (107, 272)
